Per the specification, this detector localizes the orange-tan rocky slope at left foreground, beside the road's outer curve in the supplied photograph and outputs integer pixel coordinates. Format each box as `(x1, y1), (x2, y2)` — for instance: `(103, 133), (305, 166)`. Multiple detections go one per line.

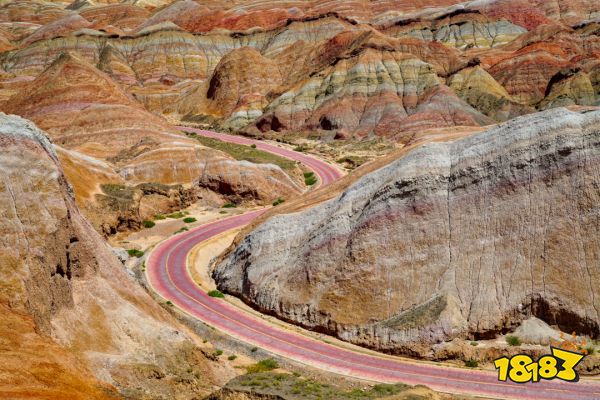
(0, 114), (232, 399)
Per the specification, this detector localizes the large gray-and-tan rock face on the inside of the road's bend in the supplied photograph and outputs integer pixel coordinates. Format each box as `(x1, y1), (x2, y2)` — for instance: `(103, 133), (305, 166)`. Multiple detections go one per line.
(214, 109), (600, 355)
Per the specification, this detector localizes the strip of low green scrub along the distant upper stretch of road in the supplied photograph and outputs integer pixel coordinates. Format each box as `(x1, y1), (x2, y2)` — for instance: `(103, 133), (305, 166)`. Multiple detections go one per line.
(186, 132), (296, 172)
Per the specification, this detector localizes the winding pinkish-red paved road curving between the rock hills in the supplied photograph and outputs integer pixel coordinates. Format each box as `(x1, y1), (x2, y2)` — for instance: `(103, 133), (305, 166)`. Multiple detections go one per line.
(146, 127), (600, 400)
